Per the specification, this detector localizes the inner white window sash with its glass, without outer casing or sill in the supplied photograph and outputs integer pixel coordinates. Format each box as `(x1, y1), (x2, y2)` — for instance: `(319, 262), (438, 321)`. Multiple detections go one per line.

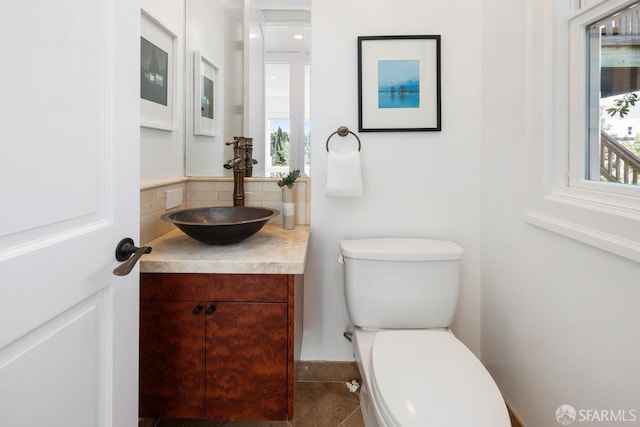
(569, 0), (640, 197)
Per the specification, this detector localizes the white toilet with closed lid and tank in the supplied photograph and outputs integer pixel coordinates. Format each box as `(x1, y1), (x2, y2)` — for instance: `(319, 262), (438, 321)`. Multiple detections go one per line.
(339, 239), (511, 427)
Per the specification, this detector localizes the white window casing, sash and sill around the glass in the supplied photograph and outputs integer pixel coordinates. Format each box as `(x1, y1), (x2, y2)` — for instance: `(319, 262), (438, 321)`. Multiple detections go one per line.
(525, 0), (640, 262)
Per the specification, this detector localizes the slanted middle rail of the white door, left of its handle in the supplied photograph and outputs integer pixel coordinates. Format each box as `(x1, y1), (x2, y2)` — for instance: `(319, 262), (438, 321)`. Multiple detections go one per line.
(0, 227), (118, 348)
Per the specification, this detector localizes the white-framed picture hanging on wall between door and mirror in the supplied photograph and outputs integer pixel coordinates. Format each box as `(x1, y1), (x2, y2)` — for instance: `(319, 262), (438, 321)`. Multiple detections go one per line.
(140, 9), (178, 131)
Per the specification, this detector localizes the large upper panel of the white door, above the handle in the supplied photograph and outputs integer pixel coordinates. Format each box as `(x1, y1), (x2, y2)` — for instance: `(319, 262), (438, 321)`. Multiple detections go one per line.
(0, 0), (111, 242)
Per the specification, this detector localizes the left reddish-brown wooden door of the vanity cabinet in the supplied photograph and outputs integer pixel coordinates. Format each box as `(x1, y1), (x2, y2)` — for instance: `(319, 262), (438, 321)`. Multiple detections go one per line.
(140, 301), (205, 418)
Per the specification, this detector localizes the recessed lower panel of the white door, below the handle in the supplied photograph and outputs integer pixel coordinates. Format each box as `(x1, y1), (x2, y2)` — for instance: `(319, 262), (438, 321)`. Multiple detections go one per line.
(0, 295), (108, 426)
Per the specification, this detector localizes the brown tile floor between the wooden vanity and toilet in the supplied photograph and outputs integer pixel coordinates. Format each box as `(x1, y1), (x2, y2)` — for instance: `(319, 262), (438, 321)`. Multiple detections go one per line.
(138, 362), (524, 427)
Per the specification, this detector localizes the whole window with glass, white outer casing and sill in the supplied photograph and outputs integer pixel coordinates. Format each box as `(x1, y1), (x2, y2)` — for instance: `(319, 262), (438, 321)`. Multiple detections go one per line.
(526, 0), (640, 262)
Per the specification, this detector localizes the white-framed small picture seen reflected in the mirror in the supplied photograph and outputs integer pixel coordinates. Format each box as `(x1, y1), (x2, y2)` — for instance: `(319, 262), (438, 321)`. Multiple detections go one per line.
(193, 50), (220, 136)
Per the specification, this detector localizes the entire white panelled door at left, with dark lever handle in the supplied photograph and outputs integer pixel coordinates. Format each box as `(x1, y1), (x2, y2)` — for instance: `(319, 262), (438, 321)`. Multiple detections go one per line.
(0, 0), (140, 427)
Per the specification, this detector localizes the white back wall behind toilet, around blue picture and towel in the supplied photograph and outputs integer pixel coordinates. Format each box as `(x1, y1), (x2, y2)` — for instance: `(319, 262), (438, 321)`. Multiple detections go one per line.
(302, 0), (482, 360)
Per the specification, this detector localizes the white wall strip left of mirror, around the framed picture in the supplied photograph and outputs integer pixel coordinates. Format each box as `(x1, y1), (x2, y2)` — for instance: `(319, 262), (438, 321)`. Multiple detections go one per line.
(140, 0), (184, 183)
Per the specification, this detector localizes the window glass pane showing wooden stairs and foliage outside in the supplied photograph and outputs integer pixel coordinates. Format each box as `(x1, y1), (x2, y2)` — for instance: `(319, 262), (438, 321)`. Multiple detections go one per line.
(585, 3), (640, 185)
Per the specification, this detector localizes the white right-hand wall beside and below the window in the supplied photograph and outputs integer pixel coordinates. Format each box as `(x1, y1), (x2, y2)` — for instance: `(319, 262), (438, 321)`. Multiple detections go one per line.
(481, 0), (640, 427)
